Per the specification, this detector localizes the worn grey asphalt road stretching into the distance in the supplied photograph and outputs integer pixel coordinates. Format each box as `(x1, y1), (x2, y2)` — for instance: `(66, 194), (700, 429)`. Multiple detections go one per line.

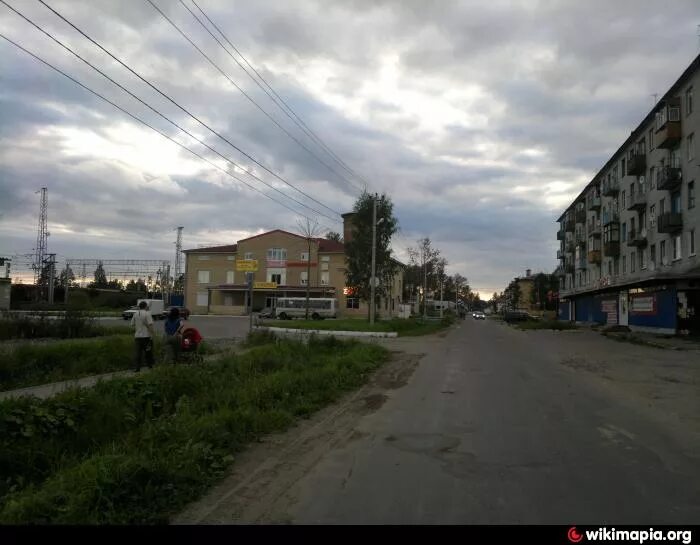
(186, 320), (700, 525)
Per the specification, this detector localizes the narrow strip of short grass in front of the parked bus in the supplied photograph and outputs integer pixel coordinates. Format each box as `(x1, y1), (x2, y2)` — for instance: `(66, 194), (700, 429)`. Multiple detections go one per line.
(262, 316), (454, 337)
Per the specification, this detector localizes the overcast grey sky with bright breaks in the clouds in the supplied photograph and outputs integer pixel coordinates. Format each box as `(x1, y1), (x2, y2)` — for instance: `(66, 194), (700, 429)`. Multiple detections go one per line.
(0, 0), (700, 298)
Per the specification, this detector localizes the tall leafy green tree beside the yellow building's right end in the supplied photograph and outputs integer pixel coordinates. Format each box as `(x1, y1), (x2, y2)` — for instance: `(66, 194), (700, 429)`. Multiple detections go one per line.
(345, 192), (399, 316)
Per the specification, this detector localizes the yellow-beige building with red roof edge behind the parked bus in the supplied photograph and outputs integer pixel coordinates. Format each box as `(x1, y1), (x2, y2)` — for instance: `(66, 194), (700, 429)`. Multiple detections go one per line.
(184, 221), (403, 316)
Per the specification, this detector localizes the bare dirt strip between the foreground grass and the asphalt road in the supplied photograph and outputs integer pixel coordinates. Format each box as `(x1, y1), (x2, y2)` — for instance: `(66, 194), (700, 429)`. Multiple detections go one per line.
(172, 348), (422, 524)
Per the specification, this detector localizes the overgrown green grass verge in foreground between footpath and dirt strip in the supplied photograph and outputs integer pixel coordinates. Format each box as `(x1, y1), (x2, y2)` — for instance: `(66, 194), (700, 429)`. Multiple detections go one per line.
(0, 337), (388, 524)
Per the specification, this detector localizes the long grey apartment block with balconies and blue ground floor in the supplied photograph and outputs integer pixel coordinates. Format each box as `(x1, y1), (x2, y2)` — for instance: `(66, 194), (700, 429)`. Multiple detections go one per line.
(557, 56), (700, 334)
